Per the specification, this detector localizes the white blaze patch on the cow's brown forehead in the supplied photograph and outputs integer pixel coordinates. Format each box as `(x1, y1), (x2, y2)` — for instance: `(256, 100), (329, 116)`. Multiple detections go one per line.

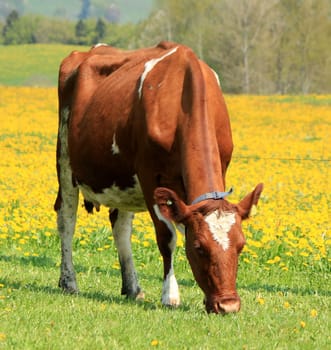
(205, 210), (236, 250)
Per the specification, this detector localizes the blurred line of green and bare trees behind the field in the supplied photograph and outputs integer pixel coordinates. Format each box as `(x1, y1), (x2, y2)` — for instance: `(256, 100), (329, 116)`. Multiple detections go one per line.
(0, 0), (331, 94)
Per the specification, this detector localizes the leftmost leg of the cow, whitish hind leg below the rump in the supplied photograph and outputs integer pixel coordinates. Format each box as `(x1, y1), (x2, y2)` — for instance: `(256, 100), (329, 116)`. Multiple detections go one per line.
(54, 106), (78, 293)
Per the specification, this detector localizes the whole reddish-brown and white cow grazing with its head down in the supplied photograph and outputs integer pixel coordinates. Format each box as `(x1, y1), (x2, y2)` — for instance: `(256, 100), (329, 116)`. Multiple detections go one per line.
(55, 42), (263, 313)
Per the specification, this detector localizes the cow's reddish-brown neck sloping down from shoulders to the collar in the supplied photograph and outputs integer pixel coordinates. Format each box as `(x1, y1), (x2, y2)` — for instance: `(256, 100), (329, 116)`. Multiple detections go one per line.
(182, 60), (224, 203)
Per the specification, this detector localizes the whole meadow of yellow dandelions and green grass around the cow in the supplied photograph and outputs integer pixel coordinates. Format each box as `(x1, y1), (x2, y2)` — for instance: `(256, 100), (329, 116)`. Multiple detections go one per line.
(0, 86), (331, 349)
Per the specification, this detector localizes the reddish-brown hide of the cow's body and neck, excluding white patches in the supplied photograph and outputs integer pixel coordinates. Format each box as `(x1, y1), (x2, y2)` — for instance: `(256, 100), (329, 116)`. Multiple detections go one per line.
(60, 43), (232, 204)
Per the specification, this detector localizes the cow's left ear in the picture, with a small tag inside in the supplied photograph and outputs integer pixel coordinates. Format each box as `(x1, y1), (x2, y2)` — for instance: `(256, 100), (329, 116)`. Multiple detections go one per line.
(154, 187), (189, 223)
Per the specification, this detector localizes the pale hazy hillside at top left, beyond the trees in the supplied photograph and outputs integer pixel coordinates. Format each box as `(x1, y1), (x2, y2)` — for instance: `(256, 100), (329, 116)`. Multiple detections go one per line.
(0, 0), (154, 23)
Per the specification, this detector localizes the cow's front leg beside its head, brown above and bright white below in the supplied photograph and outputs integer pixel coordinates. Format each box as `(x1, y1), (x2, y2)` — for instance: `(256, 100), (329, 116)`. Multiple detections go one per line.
(153, 211), (180, 306)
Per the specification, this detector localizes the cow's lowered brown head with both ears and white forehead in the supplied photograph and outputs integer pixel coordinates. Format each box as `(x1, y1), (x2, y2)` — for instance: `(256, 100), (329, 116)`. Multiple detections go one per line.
(154, 184), (263, 313)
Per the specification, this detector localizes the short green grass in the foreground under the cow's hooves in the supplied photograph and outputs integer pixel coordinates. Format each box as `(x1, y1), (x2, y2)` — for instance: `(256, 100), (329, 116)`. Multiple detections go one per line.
(0, 239), (331, 349)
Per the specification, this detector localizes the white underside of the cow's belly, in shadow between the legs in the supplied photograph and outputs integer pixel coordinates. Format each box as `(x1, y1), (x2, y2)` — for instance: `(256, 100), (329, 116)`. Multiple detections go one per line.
(78, 176), (147, 212)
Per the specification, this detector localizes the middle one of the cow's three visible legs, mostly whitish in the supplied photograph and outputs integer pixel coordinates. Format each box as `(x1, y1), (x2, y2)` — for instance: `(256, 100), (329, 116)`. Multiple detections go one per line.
(109, 209), (144, 298)
